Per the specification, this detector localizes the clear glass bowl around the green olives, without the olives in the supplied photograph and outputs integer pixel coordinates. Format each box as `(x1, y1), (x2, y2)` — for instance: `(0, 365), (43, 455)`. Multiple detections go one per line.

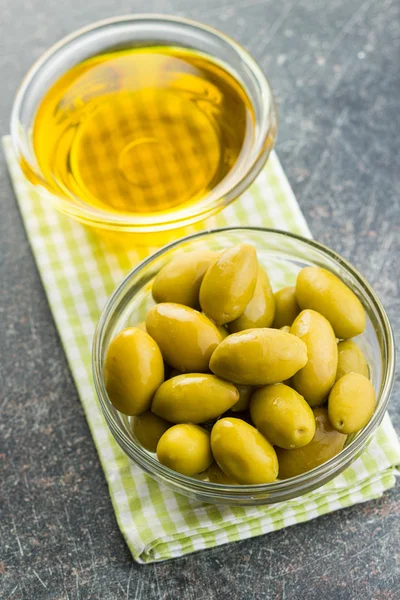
(93, 227), (395, 505)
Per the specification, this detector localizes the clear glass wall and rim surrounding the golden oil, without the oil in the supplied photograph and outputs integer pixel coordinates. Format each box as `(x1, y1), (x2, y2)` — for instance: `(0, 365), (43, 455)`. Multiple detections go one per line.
(11, 15), (277, 234)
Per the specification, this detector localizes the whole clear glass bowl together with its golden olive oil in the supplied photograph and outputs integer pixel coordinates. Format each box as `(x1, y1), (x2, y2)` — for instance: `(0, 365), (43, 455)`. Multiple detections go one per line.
(11, 15), (277, 233)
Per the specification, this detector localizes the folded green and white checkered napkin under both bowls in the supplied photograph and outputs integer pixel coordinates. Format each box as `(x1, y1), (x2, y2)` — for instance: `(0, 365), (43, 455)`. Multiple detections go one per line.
(3, 138), (400, 563)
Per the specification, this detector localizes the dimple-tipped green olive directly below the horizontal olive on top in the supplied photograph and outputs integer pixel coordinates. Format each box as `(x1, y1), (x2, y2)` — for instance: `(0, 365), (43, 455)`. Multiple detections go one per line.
(250, 383), (315, 450)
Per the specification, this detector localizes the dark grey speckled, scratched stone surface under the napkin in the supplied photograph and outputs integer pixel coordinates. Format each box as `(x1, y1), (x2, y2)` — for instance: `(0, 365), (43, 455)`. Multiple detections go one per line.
(0, 0), (400, 600)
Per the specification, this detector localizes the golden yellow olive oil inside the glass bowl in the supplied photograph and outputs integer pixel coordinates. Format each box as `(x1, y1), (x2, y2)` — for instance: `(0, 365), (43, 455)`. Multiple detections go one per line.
(33, 46), (254, 213)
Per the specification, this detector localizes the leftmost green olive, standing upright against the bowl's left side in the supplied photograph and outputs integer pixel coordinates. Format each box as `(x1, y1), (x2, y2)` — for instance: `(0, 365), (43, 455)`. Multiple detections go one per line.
(104, 327), (164, 416)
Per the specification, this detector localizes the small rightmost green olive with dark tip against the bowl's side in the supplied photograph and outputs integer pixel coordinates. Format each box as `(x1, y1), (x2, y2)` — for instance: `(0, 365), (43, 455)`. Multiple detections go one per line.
(328, 373), (376, 433)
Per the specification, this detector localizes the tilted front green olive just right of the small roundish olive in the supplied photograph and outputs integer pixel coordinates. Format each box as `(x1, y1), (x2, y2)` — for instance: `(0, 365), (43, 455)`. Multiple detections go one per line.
(211, 418), (278, 485)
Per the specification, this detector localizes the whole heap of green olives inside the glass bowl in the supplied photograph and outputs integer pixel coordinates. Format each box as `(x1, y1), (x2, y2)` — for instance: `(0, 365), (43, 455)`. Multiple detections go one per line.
(104, 244), (375, 485)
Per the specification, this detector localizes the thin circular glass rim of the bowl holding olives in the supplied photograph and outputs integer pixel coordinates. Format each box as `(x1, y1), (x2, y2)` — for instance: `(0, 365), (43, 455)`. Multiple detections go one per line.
(92, 226), (395, 501)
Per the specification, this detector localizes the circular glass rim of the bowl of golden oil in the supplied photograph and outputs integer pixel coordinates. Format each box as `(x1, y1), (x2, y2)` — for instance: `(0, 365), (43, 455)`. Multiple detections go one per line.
(10, 13), (278, 233)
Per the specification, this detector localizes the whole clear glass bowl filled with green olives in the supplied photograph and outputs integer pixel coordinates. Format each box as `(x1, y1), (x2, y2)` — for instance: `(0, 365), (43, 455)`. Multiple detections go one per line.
(93, 228), (394, 504)
